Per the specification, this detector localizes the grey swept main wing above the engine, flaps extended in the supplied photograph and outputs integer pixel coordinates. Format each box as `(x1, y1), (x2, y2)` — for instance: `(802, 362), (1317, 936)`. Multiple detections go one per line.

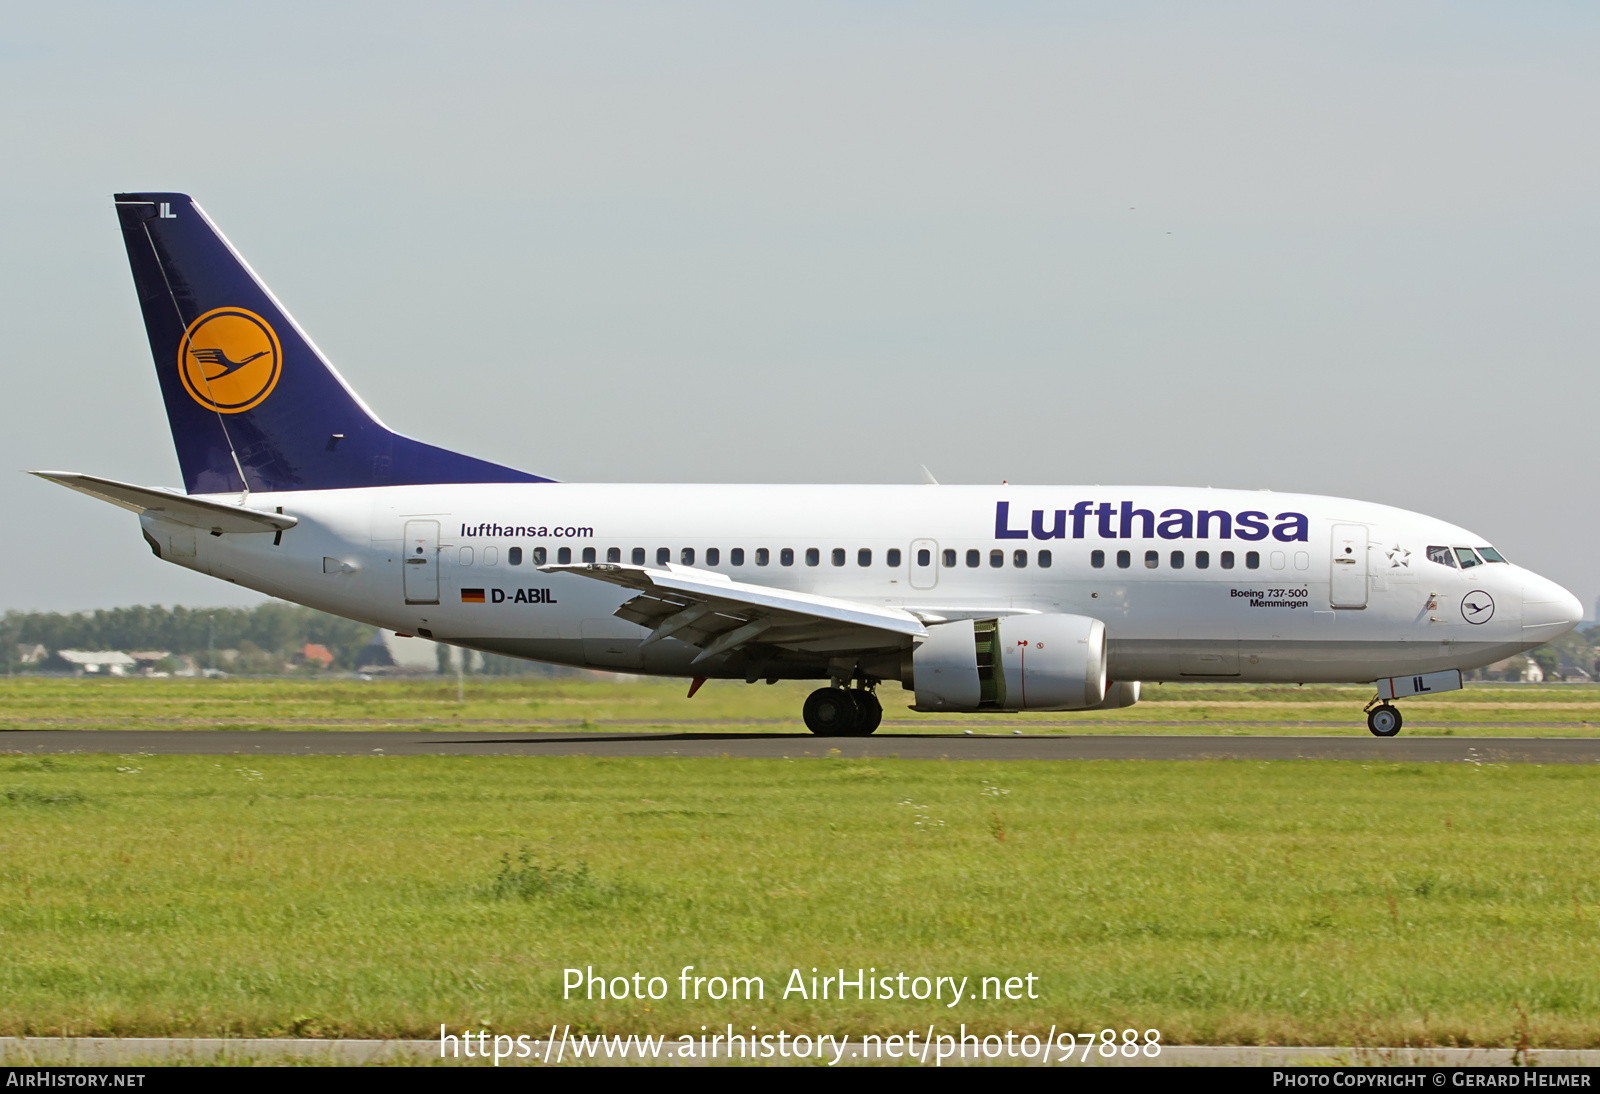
(539, 563), (928, 664)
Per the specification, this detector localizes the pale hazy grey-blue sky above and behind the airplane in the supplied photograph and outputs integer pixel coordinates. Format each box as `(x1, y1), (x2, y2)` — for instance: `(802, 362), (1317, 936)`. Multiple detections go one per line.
(0, 0), (1600, 611)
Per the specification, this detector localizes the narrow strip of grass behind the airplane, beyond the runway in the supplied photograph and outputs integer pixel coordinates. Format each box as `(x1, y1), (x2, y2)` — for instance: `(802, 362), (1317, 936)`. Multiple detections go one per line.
(0, 677), (1600, 737)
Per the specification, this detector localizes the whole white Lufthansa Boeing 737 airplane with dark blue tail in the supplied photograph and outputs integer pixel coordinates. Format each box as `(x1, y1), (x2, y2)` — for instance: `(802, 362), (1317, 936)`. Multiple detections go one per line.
(32, 194), (1582, 737)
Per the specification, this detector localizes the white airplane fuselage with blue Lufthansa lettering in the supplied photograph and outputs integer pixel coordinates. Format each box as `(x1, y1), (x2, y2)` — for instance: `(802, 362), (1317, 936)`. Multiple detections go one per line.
(142, 483), (1581, 683)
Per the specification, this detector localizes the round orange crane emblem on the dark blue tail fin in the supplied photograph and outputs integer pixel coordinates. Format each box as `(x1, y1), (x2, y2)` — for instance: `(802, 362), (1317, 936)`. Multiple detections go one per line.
(178, 307), (283, 414)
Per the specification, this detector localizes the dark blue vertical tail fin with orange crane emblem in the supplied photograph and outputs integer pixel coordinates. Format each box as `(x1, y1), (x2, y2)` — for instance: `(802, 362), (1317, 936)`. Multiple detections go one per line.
(117, 194), (550, 494)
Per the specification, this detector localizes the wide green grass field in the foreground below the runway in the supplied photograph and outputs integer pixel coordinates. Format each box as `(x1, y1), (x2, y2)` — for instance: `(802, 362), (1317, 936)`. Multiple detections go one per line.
(0, 755), (1600, 1048)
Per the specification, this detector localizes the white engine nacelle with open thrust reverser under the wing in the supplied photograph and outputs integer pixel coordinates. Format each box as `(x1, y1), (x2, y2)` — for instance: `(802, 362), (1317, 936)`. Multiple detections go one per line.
(912, 616), (1113, 712)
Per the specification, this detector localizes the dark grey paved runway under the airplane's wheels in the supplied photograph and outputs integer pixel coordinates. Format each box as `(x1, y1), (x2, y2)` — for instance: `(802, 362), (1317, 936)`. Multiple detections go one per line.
(0, 729), (1600, 763)
